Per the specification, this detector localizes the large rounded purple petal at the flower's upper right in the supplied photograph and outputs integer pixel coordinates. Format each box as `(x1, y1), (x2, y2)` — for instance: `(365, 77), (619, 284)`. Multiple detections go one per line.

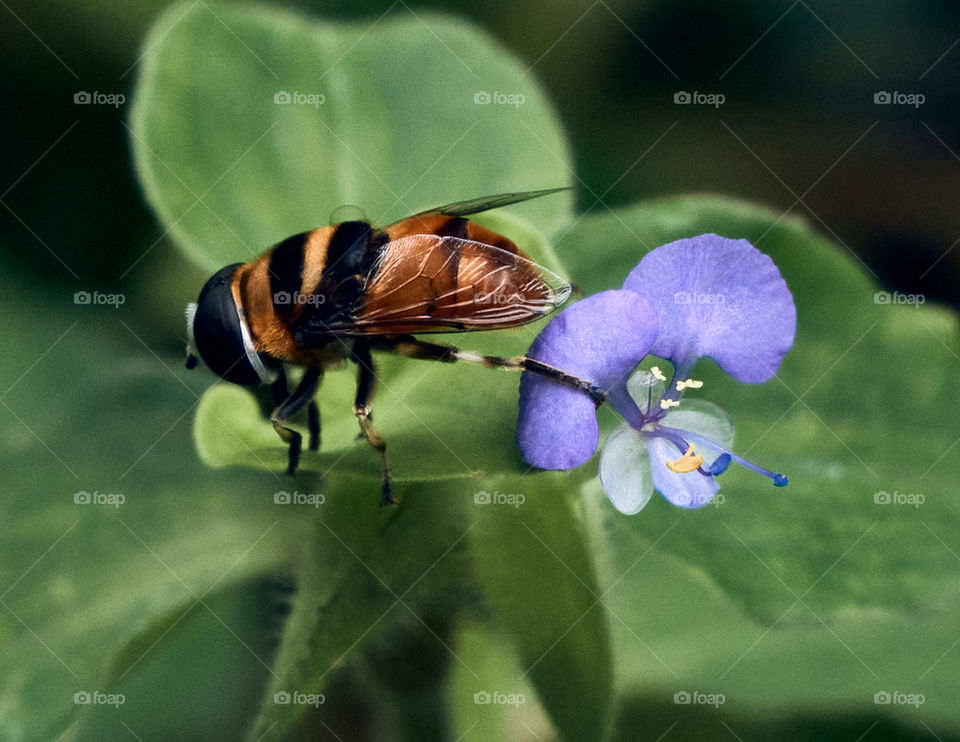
(623, 234), (797, 383)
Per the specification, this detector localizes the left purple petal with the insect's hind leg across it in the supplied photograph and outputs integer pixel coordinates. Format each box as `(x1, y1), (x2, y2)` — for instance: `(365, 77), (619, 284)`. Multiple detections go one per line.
(517, 291), (657, 469)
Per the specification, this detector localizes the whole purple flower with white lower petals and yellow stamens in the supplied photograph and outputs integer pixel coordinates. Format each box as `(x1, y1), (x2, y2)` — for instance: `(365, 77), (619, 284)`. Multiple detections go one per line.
(517, 234), (796, 513)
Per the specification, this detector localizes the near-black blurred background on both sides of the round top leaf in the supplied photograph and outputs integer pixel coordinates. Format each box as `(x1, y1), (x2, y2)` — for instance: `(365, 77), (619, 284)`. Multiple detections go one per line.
(0, 0), (960, 326)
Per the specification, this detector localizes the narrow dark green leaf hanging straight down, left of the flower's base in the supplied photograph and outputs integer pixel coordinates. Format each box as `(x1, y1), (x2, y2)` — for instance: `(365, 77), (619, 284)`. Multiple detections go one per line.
(471, 475), (611, 740)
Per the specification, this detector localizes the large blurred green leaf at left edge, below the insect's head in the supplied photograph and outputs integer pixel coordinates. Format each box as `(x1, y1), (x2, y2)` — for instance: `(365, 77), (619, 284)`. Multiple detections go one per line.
(0, 266), (302, 739)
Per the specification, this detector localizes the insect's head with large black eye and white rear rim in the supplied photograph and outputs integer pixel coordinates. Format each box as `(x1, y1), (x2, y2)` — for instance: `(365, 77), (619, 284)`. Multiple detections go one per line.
(187, 263), (281, 386)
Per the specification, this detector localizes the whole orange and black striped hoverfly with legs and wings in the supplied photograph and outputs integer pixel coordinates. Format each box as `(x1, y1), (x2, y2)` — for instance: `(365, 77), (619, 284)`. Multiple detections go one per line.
(187, 188), (604, 505)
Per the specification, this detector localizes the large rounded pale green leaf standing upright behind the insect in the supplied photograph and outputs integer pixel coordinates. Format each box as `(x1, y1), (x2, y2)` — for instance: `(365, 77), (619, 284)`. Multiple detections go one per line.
(132, 3), (571, 271)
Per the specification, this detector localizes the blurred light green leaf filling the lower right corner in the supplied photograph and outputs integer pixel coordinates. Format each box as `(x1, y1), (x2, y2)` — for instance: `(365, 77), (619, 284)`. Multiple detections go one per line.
(586, 484), (960, 739)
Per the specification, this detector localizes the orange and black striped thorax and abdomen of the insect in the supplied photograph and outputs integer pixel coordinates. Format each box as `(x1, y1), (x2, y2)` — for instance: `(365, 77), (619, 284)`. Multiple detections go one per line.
(231, 194), (564, 366)
